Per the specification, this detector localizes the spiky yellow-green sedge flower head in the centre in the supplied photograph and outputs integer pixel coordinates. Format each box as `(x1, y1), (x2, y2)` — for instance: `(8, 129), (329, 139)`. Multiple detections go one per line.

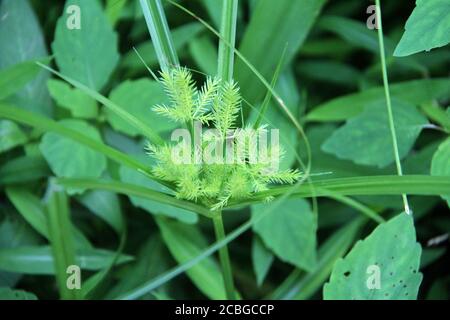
(147, 68), (301, 210)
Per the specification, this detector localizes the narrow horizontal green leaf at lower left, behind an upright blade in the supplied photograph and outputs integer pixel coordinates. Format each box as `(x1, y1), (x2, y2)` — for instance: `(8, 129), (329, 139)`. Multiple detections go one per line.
(0, 246), (132, 275)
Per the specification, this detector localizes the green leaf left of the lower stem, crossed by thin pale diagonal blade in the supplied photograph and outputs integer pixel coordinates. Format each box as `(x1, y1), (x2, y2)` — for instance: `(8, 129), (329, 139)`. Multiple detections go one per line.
(156, 217), (225, 300)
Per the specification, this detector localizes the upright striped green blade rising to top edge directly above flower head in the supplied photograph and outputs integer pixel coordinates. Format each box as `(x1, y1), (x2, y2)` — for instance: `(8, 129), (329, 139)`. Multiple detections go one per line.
(218, 0), (238, 81)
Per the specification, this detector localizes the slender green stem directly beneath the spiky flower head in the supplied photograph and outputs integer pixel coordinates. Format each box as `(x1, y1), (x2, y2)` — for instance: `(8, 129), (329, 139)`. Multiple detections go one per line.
(212, 210), (235, 300)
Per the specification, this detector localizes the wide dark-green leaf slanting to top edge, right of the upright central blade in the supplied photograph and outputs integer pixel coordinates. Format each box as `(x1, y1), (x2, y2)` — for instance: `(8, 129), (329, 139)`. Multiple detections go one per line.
(235, 0), (325, 104)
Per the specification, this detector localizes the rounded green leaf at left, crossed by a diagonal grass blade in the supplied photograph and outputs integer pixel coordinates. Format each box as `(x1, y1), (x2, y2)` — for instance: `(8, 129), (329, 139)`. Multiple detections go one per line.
(40, 120), (106, 184)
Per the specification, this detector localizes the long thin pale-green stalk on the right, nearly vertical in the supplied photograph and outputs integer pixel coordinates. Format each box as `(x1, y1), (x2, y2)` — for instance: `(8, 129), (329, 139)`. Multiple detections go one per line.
(375, 0), (411, 214)
